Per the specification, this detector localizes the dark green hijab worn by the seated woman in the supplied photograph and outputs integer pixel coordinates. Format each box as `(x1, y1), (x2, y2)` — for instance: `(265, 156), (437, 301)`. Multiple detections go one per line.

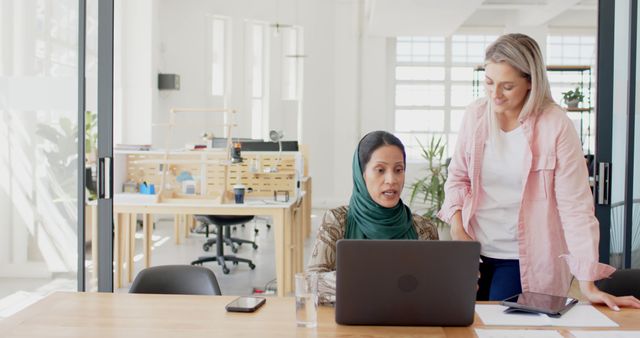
(344, 131), (418, 239)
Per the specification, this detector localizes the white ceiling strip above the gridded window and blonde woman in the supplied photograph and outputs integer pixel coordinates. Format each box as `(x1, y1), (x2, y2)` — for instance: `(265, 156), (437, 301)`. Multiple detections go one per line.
(365, 0), (598, 36)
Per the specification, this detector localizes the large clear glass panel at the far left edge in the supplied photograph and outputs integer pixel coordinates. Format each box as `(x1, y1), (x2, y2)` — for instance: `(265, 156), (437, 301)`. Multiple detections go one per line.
(0, 0), (82, 304)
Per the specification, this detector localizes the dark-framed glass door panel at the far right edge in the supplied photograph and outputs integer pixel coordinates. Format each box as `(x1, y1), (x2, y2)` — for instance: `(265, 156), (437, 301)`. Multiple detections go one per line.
(594, 0), (640, 268)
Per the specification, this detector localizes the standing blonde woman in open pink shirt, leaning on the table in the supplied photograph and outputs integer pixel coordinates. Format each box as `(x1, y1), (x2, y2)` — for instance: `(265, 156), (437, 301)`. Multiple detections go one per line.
(438, 34), (640, 310)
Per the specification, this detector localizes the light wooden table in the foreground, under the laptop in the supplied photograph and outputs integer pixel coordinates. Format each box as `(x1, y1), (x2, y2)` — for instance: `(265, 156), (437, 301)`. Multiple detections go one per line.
(0, 292), (640, 338)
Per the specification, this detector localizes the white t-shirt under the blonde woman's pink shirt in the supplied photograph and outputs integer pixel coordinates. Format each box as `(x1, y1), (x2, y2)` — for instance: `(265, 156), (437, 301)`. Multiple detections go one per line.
(471, 126), (528, 259)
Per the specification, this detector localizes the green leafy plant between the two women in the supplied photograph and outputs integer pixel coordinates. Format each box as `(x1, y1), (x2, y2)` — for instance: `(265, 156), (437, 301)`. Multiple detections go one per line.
(409, 137), (447, 227)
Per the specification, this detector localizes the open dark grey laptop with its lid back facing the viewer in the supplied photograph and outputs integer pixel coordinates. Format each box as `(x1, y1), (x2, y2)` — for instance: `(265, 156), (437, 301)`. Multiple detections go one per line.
(336, 239), (480, 326)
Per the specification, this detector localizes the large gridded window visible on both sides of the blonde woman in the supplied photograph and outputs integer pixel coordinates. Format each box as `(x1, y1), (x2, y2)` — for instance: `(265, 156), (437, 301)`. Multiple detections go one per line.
(394, 33), (596, 160)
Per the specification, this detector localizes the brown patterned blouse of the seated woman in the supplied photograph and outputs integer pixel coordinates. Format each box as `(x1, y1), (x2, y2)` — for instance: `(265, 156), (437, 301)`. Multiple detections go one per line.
(306, 206), (438, 304)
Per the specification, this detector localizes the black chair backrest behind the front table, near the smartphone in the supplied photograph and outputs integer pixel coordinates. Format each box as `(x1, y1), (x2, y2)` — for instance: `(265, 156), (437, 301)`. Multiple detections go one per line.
(129, 265), (222, 295)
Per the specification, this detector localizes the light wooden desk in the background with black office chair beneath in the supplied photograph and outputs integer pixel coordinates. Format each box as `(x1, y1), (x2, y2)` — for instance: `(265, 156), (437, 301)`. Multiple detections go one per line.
(113, 195), (304, 296)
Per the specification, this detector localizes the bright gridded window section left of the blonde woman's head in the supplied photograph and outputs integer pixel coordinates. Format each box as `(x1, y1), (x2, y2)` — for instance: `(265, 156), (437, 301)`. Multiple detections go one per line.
(394, 34), (497, 160)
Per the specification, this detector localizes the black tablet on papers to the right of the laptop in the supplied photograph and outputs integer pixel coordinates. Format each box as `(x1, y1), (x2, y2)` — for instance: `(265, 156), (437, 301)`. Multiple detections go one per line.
(500, 292), (578, 317)
